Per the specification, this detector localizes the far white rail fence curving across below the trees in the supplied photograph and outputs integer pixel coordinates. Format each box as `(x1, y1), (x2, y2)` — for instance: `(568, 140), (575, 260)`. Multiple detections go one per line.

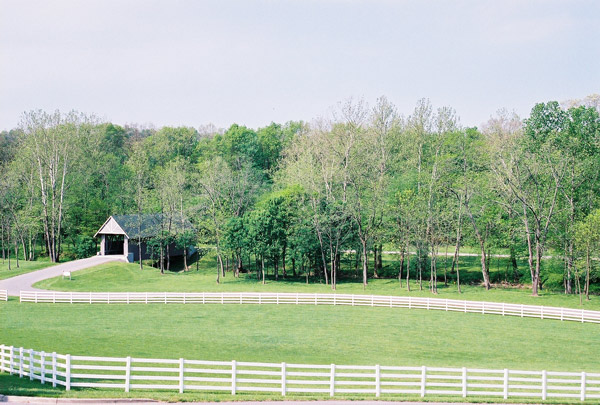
(20, 291), (600, 323)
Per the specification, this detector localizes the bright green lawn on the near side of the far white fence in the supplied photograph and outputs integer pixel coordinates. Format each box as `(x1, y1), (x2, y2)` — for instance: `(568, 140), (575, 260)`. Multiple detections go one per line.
(0, 300), (600, 403)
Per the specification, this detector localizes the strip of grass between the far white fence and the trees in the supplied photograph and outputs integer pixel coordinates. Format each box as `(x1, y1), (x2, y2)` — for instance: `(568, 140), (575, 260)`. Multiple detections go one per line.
(35, 252), (600, 310)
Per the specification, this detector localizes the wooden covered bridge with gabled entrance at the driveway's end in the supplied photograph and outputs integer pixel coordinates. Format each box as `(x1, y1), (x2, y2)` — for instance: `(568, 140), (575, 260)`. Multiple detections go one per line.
(94, 214), (194, 263)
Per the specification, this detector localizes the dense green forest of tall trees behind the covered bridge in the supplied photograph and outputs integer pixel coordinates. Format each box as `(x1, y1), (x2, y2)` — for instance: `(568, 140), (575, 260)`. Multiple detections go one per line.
(0, 95), (600, 297)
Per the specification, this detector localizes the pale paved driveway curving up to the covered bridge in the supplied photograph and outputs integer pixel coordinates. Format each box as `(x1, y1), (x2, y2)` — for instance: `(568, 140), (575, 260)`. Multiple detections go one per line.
(0, 256), (125, 296)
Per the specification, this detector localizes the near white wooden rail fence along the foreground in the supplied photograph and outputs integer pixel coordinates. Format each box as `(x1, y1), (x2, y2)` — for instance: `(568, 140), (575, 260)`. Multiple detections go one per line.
(0, 345), (600, 401)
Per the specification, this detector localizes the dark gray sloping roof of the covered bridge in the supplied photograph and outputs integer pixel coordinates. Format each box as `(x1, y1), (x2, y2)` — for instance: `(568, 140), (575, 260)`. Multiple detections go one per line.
(105, 214), (193, 239)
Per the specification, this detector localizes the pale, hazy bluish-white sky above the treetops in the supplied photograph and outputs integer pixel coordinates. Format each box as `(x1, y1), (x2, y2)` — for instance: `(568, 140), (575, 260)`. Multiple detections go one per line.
(0, 0), (600, 130)
